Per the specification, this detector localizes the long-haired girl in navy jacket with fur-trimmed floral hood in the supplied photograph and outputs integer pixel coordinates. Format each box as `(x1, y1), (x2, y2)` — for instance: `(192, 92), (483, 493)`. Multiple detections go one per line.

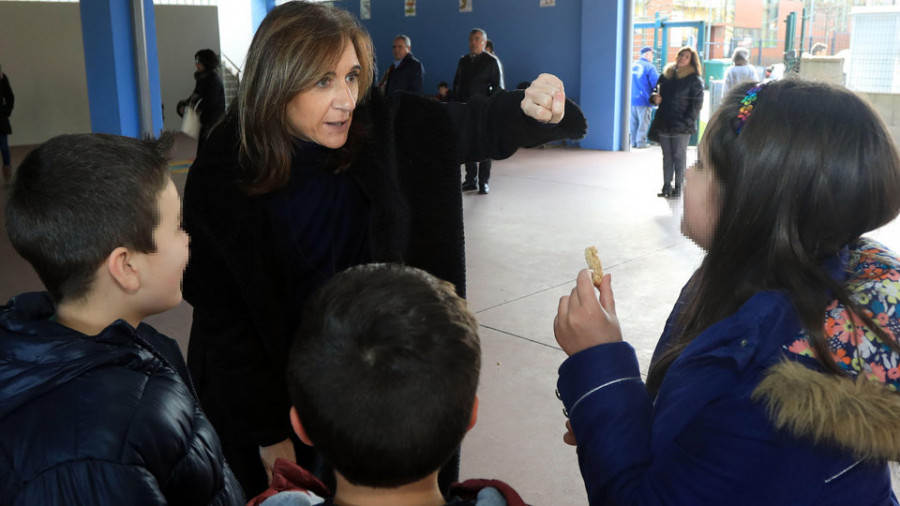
(554, 79), (900, 506)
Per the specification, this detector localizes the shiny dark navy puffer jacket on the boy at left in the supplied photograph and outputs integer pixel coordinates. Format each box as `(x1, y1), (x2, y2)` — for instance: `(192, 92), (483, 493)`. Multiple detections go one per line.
(0, 293), (243, 505)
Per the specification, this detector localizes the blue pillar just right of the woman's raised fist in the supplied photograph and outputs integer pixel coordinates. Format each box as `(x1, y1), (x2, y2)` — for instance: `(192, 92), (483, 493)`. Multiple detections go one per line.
(581, 0), (631, 151)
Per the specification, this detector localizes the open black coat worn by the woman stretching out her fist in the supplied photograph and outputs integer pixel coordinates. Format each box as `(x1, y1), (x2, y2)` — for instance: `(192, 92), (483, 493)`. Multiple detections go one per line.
(184, 91), (587, 492)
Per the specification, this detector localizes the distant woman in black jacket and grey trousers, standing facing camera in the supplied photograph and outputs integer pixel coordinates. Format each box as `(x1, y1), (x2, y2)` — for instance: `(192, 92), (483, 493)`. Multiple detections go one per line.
(650, 47), (703, 198)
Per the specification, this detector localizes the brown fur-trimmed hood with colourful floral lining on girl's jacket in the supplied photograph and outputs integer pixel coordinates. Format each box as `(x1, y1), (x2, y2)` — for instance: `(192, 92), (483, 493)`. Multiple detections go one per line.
(753, 239), (900, 462)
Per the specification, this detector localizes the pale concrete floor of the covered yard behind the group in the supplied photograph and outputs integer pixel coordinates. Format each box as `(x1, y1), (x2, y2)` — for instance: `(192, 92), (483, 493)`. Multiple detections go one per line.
(0, 136), (900, 506)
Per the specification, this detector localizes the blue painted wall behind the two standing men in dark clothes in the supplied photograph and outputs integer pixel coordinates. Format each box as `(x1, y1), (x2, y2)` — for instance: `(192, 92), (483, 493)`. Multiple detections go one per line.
(344, 0), (584, 102)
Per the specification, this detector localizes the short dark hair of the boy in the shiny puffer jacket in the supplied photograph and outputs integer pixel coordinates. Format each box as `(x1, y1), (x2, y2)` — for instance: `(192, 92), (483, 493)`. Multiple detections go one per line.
(6, 134), (172, 303)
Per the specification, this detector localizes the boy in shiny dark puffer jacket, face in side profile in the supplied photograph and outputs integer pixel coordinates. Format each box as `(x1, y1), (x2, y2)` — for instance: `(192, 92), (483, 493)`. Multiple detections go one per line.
(0, 134), (243, 505)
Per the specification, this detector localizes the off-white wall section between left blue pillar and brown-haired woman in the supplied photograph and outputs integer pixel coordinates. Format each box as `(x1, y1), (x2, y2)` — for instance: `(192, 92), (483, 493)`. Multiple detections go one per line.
(153, 5), (220, 130)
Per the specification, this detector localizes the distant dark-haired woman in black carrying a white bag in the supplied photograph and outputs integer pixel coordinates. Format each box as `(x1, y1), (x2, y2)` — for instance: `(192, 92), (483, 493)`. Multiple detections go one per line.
(178, 49), (225, 153)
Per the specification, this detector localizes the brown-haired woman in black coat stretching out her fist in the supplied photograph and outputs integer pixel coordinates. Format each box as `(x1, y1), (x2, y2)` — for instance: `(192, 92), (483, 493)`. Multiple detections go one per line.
(184, 2), (586, 497)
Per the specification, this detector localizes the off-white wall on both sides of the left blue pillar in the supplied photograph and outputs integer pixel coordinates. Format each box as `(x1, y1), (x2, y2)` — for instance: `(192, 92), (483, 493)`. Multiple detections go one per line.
(0, 2), (219, 146)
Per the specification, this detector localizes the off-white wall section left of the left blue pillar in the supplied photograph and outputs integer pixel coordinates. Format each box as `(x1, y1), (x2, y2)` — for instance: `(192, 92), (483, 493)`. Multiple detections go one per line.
(0, 2), (91, 146)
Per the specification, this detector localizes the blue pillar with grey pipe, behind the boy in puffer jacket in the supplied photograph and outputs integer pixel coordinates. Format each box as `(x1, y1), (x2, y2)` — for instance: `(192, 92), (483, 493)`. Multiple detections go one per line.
(79, 0), (162, 137)
